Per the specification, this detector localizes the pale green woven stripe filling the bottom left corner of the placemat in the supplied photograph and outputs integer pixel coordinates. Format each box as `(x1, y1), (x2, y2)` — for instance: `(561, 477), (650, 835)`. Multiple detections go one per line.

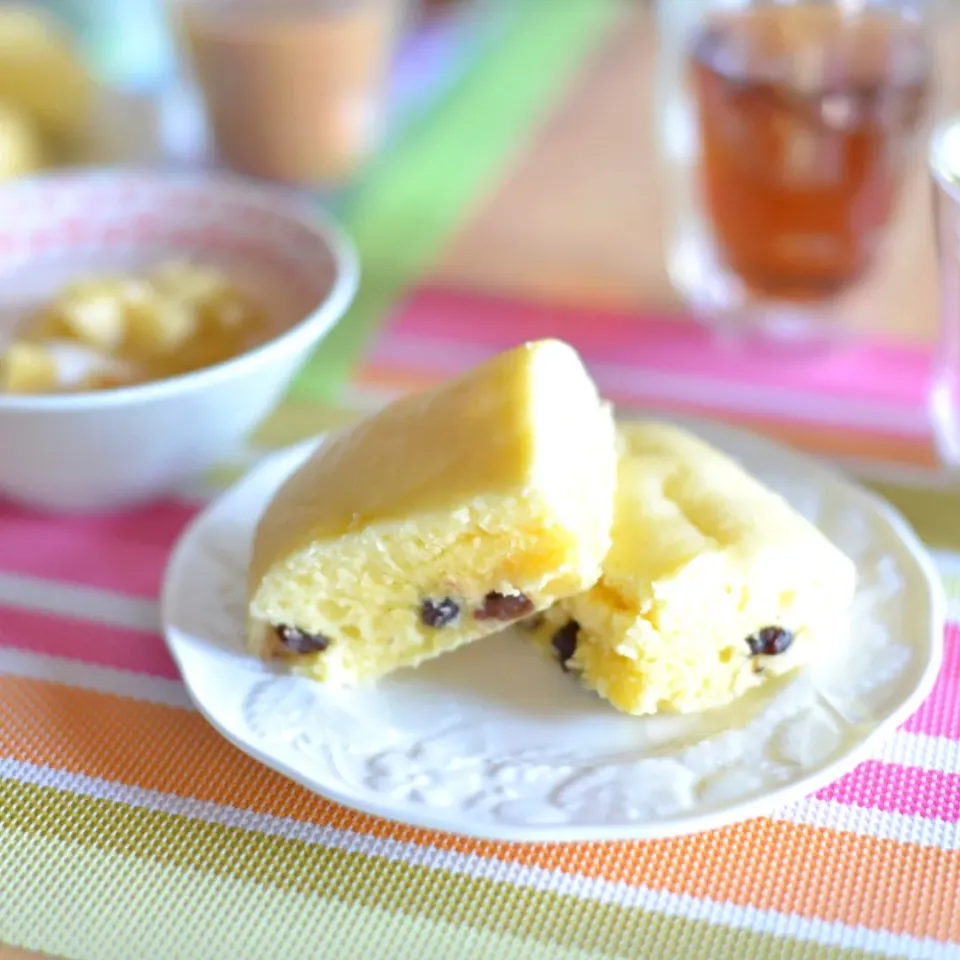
(0, 830), (596, 960)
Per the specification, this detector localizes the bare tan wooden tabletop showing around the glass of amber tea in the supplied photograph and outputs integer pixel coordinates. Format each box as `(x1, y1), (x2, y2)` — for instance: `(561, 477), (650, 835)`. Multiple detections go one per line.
(436, 2), (960, 342)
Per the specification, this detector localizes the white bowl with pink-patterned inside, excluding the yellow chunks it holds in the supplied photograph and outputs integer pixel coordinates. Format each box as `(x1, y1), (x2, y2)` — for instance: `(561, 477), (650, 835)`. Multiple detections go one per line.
(0, 170), (358, 511)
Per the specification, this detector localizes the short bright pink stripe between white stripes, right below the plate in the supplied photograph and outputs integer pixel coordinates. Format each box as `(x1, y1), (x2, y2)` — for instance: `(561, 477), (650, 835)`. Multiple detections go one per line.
(817, 760), (960, 823)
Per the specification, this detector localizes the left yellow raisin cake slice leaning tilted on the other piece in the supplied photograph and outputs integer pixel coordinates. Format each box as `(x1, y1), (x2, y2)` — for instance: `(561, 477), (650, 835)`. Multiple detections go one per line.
(248, 340), (616, 684)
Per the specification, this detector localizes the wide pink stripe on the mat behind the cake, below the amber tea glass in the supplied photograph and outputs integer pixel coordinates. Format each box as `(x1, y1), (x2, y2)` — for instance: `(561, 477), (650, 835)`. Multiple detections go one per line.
(376, 287), (930, 408)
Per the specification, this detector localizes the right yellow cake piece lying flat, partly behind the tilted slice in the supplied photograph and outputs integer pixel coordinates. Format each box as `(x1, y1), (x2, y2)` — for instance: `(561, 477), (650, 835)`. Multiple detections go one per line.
(535, 422), (855, 714)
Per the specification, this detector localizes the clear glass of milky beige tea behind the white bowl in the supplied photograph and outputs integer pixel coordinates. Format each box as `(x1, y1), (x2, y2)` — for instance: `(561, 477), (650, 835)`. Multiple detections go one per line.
(169, 0), (405, 188)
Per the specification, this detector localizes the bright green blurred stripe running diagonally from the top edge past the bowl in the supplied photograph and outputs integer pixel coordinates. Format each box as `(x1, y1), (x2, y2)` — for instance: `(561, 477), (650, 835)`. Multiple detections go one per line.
(292, 0), (617, 400)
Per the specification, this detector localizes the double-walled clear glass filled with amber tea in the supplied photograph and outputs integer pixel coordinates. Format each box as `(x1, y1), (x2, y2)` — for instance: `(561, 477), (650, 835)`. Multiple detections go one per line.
(657, 0), (935, 345)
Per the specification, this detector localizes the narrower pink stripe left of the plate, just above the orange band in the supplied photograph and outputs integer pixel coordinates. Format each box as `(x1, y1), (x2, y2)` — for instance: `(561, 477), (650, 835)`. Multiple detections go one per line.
(0, 607), (180, 680)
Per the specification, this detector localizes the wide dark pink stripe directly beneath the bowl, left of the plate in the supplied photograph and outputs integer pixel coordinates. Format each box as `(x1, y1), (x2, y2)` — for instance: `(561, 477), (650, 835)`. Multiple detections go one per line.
(0, 501), (196, 597)
